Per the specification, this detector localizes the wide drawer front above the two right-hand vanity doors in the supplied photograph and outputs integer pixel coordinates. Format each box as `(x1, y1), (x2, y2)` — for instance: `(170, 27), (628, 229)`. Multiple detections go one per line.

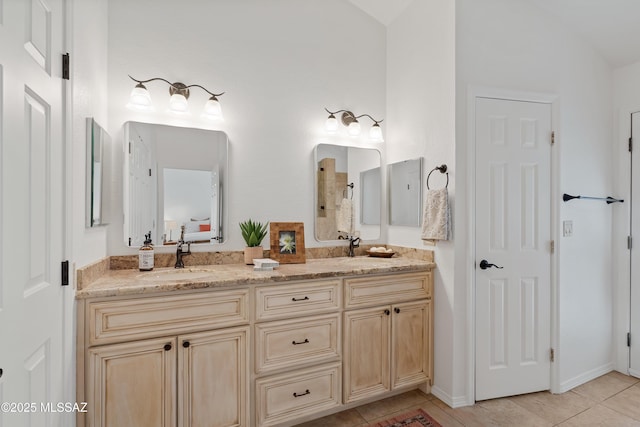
(344, 271), (433, 308)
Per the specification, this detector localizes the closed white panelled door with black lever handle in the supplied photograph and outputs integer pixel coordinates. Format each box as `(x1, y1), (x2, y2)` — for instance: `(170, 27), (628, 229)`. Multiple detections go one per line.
(475, 98), (551, 400)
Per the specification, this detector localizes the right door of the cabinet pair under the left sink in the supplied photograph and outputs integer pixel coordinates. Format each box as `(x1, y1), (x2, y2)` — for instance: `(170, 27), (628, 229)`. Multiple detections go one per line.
(180, 326), (249, 427)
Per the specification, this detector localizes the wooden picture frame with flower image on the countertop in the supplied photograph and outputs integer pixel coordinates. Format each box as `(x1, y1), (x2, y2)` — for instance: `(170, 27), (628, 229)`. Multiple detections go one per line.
(269, 222), (306, 264)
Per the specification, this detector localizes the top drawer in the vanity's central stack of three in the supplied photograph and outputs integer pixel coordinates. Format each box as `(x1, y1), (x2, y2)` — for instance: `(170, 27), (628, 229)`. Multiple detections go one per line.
(256, 280), (340, 321)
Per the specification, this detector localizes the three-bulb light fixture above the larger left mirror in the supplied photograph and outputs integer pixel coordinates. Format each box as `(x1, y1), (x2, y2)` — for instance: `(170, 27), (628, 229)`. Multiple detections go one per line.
(127, 76), (224, 119)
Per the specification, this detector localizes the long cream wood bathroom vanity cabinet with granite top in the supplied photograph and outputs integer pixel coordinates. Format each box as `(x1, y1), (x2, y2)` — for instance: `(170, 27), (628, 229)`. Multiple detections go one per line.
(78, 259), (434, 427)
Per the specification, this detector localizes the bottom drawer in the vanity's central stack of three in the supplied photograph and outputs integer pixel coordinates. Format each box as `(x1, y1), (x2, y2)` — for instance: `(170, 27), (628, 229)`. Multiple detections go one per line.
(256, 363), (341, 426)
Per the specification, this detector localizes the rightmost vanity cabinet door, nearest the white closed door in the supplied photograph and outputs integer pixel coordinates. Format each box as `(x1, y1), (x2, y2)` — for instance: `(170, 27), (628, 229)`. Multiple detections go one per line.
(391, 300), (431, 389)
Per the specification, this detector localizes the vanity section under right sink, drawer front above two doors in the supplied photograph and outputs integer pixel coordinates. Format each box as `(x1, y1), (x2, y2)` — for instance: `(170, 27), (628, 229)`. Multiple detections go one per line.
(343, 274), (433, 404)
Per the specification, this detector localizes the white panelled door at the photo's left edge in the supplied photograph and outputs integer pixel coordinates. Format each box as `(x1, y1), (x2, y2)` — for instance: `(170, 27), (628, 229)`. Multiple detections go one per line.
(0, 0), (71, 427)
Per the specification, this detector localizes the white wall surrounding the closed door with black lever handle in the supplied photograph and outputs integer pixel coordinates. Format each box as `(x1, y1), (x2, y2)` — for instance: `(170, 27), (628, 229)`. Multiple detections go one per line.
(453, 0), (620, 402)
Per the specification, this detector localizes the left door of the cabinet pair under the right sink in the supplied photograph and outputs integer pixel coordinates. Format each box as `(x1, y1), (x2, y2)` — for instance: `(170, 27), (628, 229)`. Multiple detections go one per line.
(343, 306), (391, 403)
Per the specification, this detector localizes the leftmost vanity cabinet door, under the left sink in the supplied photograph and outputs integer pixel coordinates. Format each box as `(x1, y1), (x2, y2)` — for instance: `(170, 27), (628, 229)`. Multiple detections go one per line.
(87, 338), (176, 427)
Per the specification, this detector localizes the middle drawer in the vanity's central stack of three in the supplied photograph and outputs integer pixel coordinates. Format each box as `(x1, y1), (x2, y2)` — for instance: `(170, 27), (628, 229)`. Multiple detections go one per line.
(255, 314), (341, 374)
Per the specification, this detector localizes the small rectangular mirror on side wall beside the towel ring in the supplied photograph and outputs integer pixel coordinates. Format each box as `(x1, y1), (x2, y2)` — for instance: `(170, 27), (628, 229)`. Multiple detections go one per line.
(388, 157), (422, 227)
